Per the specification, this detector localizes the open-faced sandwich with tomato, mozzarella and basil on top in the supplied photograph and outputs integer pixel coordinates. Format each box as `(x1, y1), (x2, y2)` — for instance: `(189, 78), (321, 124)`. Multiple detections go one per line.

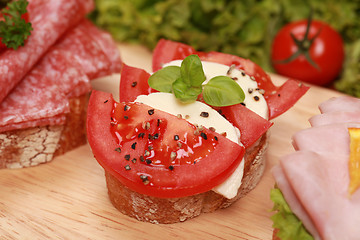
(87, 40), (308, 223)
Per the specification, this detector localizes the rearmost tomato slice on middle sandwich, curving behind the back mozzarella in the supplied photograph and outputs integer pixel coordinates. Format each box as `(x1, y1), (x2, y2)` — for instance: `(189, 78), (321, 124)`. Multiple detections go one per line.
(153, 39), (309, 120)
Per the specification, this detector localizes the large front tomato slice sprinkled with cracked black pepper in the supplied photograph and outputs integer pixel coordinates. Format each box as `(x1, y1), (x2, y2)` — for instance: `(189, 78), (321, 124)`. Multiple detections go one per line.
(87, 91), (244, 198)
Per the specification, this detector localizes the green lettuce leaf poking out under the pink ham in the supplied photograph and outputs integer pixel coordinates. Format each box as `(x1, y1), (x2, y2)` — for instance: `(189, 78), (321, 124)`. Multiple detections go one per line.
(270, 188), (314, 240)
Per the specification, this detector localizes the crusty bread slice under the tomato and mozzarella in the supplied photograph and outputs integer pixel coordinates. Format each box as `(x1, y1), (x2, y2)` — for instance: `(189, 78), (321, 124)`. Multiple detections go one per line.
(105, 134), (269, 223)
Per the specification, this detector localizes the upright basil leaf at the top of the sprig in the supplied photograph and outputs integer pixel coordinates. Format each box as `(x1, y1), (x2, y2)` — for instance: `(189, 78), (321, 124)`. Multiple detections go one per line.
(180, 55), (206, 87)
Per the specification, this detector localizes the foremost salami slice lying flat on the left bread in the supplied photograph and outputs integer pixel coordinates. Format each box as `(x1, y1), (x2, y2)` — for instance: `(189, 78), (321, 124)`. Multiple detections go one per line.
(0, 50), (90, 132)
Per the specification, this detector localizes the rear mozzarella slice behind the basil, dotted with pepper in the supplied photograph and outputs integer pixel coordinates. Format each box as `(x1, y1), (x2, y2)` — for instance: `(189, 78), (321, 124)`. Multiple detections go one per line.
(164, 60), (269, 119)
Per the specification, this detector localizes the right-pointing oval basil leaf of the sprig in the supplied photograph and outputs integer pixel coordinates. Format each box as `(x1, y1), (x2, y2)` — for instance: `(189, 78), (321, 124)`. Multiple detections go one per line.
(203, 76), (245, 107)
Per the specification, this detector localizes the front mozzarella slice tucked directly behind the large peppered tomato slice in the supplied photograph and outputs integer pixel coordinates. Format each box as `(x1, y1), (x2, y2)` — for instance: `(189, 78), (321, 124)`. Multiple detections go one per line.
(135, 92), (244, 199)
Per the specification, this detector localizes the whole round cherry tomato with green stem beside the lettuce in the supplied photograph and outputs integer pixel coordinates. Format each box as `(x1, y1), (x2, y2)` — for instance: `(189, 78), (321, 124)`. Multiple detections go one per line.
(271, 19), (344, 85)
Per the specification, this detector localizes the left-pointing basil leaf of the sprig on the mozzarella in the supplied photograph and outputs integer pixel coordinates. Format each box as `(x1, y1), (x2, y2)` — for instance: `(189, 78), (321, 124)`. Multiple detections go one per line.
(148, 66), (180, 93)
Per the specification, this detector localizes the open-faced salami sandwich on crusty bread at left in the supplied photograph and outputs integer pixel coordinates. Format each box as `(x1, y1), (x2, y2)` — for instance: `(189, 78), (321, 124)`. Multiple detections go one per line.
(0, 0), (121, 169)
